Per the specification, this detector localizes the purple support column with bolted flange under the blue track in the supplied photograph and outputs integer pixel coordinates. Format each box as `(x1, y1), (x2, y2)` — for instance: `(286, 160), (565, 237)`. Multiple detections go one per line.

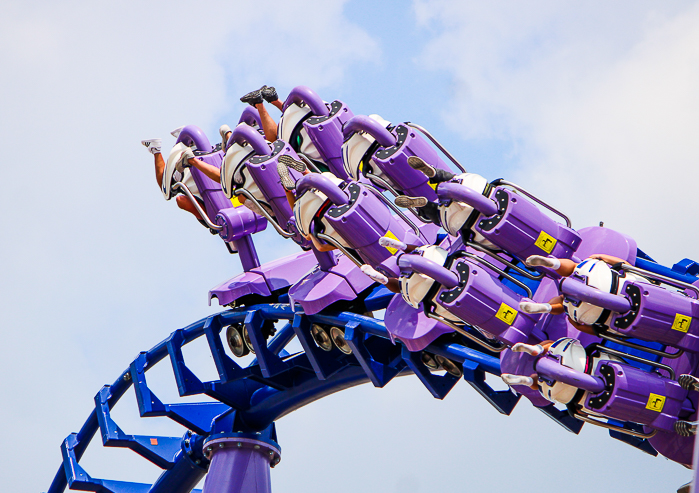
(204, 433), (281, 493)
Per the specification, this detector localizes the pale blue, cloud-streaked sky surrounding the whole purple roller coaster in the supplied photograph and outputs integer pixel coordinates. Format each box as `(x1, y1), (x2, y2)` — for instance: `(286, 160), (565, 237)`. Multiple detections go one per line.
(0, 0), (699, 493)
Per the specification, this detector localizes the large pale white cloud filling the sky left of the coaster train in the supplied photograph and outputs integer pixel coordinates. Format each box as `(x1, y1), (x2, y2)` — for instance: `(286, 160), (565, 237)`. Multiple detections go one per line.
(0, 0), (378, 491)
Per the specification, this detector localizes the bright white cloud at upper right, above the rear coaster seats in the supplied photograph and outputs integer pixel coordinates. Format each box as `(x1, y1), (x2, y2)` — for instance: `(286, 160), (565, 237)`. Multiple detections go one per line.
(415, 0), (699, 263)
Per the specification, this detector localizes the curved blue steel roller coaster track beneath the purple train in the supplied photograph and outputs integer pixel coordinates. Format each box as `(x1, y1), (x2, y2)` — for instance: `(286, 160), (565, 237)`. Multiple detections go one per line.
(48, 304), (516, 493)
